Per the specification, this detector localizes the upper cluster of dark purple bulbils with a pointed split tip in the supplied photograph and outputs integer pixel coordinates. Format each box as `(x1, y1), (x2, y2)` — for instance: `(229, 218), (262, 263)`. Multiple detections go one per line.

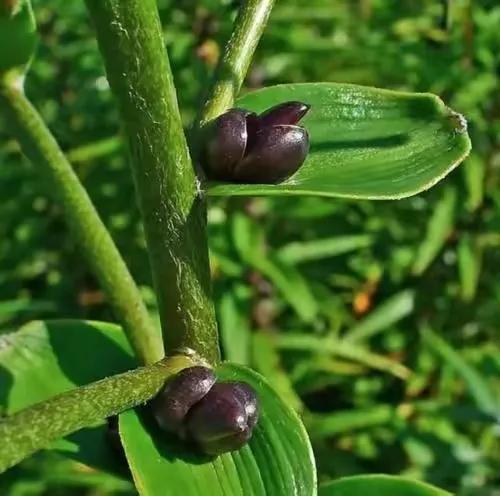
(204, 102), (310, 184)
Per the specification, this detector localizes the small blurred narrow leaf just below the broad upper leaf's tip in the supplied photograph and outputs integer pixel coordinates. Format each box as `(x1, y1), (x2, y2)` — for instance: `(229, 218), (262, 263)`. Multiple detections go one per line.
(412, 188), (457, 275)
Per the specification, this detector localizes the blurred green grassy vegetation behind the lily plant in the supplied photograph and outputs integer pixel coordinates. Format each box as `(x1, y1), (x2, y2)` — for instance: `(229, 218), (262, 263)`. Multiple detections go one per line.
(0, 0), (500, 496)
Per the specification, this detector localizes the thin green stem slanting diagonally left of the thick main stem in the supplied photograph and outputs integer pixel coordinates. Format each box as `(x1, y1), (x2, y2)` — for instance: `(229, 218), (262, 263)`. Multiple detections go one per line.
(0, 80), (163, 364)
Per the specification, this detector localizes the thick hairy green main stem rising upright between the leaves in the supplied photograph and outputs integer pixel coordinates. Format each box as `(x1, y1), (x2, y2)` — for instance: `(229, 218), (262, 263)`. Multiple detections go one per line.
(86, 0), (219, 363)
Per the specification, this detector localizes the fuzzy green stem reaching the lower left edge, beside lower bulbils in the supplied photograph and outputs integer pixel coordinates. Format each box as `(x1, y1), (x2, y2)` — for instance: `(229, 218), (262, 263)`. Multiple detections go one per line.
(0, 355), (195, 473)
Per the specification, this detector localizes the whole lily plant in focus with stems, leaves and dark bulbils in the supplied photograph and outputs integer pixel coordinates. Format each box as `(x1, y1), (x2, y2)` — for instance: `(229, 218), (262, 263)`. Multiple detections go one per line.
(0, 0), (470, 496)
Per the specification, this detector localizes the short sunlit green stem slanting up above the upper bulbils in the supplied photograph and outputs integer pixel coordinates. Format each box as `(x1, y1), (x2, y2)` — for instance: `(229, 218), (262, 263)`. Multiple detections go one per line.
(200, 0), (274, 126)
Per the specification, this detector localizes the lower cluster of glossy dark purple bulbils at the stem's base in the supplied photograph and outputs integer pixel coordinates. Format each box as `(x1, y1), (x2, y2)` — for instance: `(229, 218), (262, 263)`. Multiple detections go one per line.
(153, 367), (259, 455)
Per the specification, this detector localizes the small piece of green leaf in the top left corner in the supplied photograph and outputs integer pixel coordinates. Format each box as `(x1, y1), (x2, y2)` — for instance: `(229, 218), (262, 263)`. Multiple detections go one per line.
(0, 0), (38, 74)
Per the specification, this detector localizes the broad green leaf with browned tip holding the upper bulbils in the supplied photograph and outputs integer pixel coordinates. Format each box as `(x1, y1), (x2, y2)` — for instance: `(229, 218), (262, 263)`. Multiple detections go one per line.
(208, 83), (470, 199)
